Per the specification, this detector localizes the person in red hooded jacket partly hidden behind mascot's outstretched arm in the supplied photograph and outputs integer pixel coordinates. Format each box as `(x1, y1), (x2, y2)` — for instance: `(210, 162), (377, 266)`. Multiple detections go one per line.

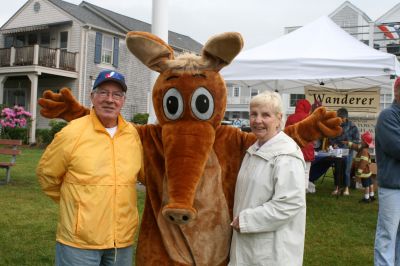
(285, 99), (315, 192)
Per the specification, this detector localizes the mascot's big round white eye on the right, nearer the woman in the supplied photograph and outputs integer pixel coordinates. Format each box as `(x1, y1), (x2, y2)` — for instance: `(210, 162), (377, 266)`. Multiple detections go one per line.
(190, 87), (214, 120)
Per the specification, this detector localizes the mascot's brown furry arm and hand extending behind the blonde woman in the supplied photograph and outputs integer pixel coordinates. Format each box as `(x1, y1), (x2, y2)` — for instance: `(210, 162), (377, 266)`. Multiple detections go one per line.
(284, 107), (342, 147)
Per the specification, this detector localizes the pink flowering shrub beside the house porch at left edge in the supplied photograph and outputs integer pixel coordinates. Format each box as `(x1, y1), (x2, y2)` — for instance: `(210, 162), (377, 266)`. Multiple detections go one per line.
(0, 105), (32, 128)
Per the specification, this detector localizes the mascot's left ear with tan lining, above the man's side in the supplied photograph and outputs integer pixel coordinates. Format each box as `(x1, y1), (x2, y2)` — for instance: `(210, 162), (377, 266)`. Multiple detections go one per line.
(126, 31), (174, 73)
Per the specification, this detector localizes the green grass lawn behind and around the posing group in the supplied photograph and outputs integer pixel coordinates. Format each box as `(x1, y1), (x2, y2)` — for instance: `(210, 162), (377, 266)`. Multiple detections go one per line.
(0, 148), (378, 266)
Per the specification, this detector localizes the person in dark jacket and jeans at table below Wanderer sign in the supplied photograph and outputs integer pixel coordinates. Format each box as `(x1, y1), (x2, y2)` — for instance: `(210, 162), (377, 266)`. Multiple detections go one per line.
(329, 107), (360, 196)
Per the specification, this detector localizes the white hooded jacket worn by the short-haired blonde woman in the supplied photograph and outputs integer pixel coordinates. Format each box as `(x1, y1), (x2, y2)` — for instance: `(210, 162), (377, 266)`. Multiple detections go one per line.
(229, 132), (306, 266)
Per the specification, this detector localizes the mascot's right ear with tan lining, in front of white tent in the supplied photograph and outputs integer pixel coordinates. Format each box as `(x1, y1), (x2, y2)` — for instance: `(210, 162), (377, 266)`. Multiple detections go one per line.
(202, 32), (243, 71)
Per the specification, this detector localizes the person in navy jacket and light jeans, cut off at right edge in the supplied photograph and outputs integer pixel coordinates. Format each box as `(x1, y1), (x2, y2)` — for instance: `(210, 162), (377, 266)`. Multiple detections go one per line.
(374, 78), (400, 266)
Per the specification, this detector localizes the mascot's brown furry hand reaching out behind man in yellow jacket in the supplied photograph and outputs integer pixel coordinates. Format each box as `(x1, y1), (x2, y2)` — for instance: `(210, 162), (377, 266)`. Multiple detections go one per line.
(38, 88), (90, 122)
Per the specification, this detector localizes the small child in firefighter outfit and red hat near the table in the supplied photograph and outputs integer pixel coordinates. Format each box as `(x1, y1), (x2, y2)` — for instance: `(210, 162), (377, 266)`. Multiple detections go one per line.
(343, 131), (375, 203)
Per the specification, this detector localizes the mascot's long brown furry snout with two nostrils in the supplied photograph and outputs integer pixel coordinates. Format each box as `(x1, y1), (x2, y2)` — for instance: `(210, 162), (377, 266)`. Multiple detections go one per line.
(162, 121), (215, 224)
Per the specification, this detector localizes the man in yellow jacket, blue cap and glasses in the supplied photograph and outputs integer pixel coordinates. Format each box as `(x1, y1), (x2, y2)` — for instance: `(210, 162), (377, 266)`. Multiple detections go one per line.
(37, 70), (143, 265)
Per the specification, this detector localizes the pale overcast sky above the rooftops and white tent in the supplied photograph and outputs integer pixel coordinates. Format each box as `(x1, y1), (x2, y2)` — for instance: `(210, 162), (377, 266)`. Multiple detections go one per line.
(0, 0), (400, 49)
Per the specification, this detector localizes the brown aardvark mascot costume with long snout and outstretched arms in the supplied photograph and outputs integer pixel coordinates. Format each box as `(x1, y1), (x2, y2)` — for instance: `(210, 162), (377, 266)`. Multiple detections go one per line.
(39, 32), (341, 266)
